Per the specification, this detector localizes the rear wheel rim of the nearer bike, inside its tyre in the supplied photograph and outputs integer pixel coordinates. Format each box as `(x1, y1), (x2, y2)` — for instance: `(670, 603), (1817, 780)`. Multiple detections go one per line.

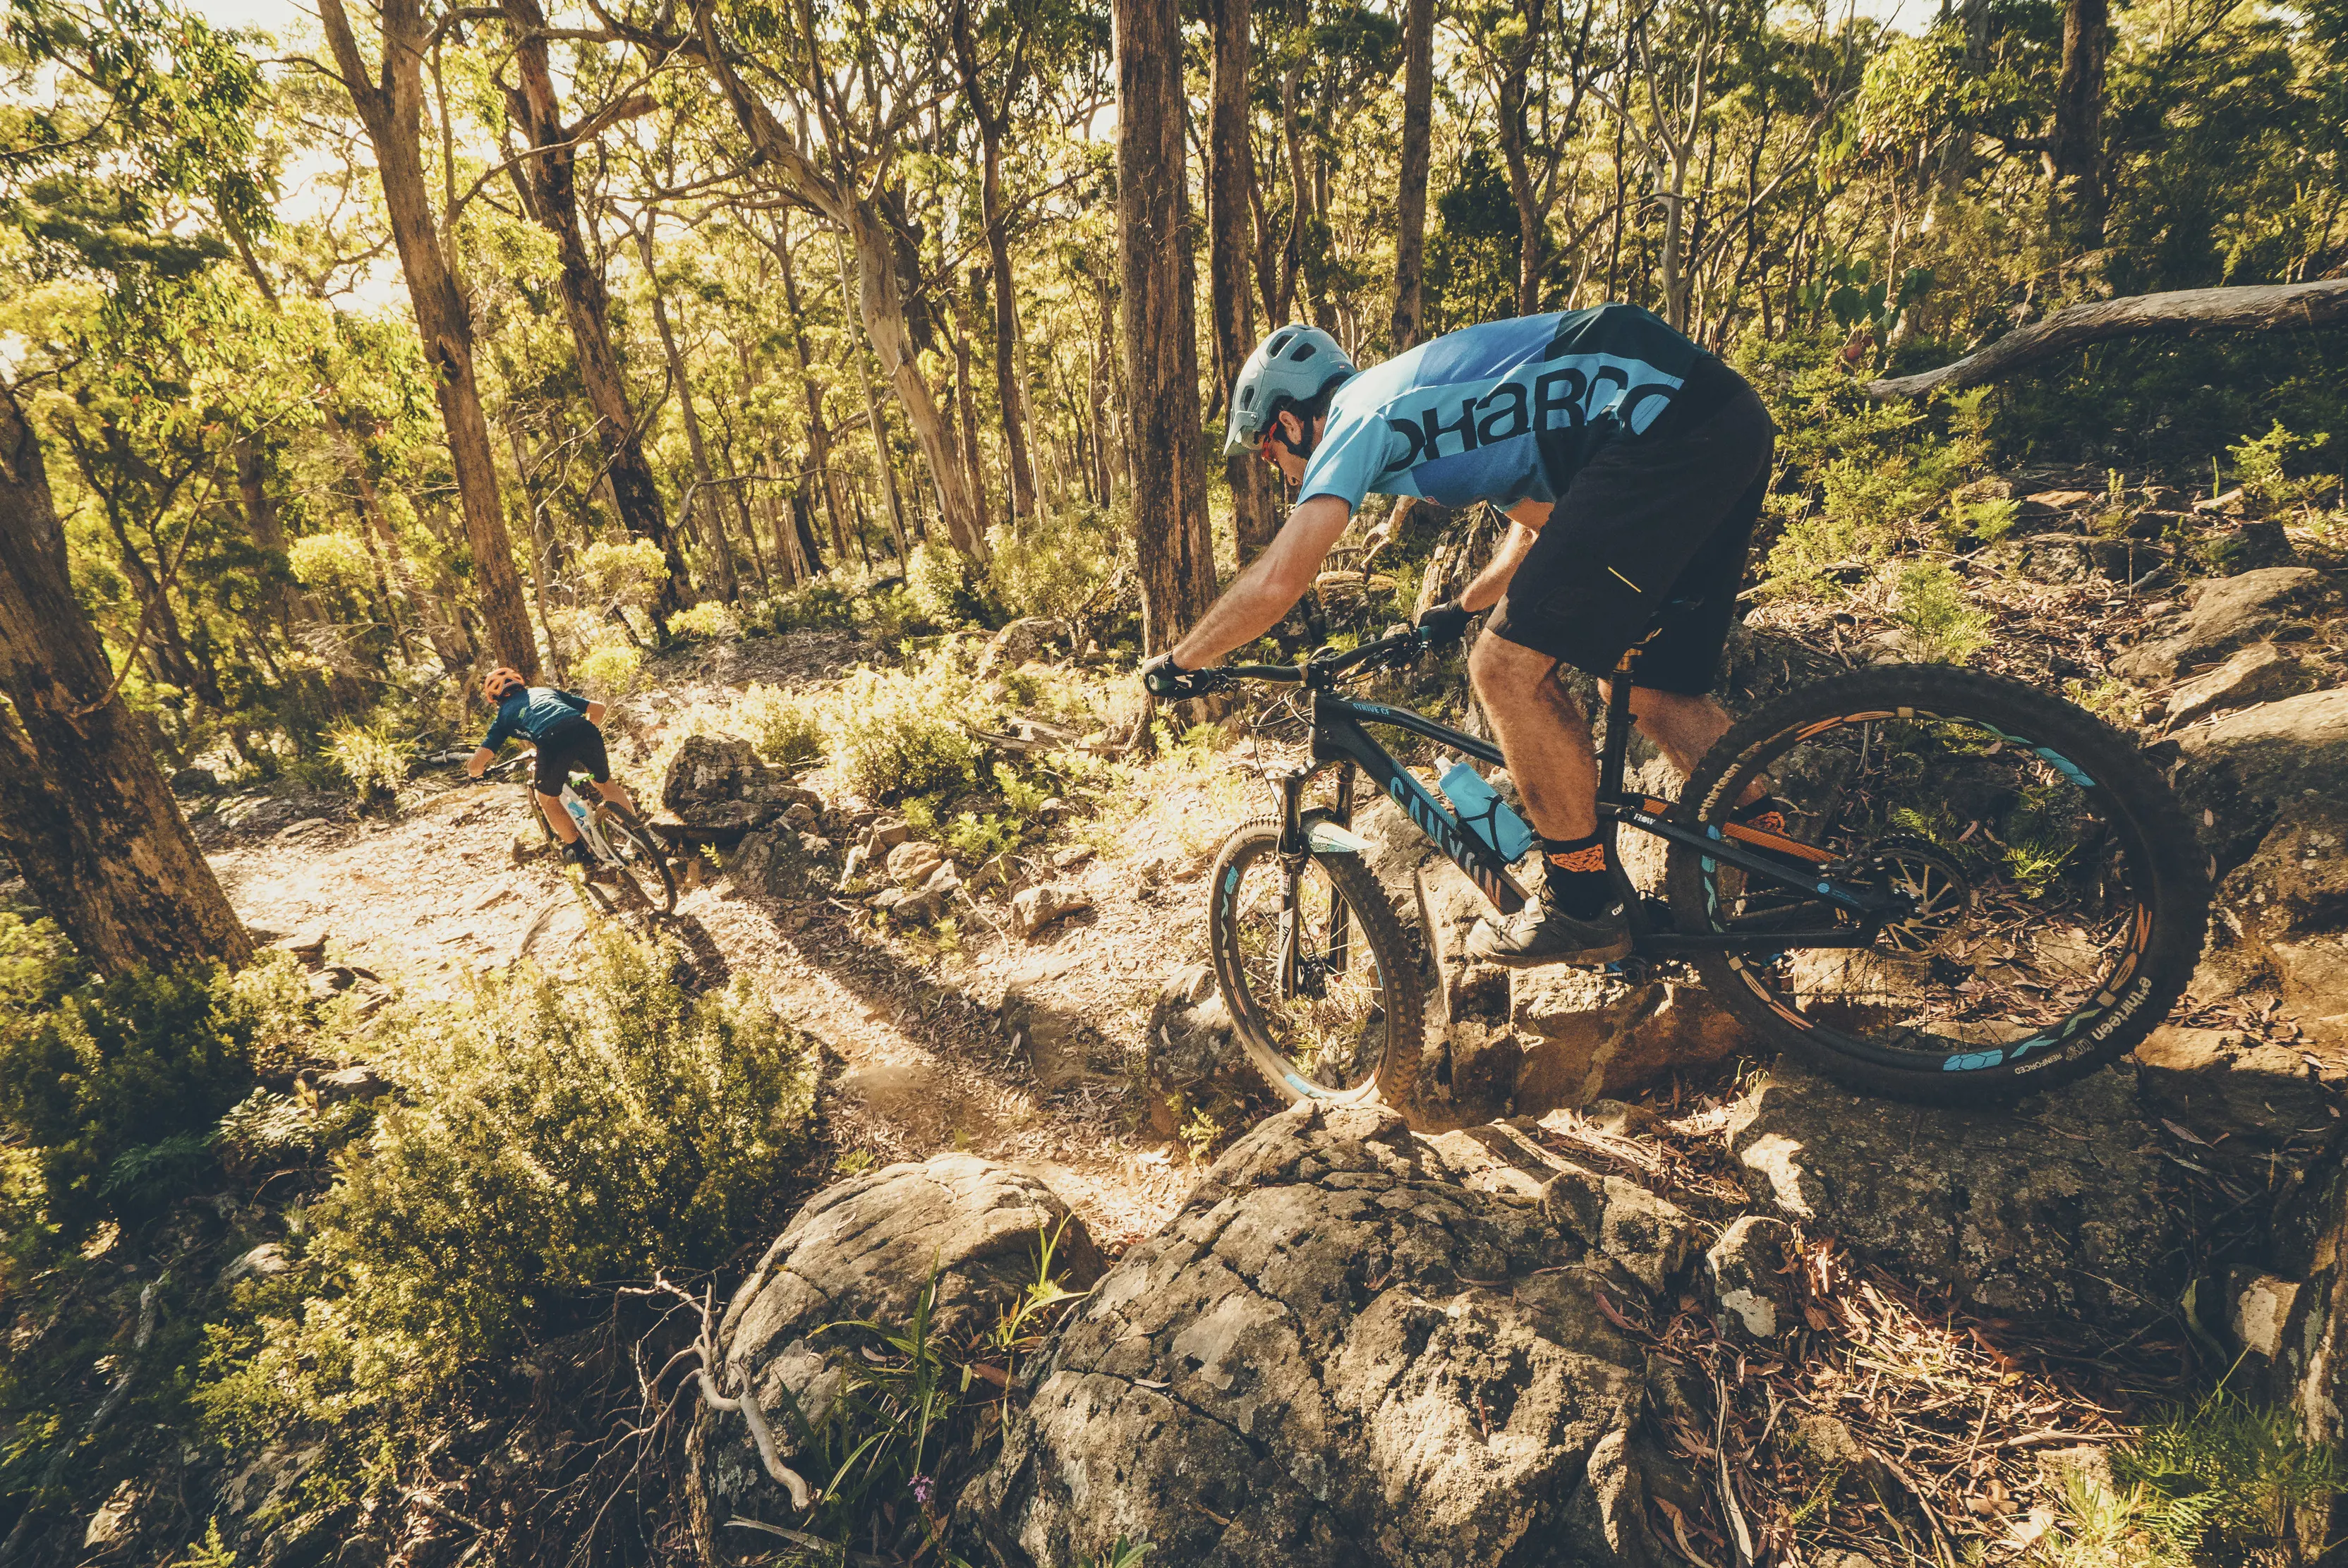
(1700, 704), (2155, 1073)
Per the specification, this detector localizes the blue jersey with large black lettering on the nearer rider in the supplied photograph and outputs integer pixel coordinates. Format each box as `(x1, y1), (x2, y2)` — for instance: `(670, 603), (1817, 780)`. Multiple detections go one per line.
(1296, 305), (1702, 521)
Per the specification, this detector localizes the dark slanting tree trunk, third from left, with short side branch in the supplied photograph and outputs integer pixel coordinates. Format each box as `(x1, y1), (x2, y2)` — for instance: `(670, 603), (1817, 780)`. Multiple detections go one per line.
(502, 0), (681, 624)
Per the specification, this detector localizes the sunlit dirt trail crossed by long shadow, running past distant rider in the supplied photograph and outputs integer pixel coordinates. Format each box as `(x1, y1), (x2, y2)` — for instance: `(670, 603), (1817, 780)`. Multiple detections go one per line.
(200, 638), (1197, 1244)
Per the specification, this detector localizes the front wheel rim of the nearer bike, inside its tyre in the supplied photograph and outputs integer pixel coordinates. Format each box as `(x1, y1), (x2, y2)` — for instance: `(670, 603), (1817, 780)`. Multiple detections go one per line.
(1214, 826), (1404, 1098)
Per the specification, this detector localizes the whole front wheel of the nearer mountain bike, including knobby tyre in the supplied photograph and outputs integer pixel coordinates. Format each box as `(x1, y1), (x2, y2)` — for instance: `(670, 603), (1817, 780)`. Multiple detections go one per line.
(1207, 812), (1425, 1105)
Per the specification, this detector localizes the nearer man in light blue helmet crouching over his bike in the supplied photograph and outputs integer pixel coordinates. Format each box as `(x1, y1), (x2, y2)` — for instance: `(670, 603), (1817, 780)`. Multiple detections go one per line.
(1144, 305), (1782, 967)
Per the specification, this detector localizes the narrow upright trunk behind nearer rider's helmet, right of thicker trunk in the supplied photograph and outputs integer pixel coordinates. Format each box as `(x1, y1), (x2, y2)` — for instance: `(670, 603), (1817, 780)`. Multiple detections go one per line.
(1207, 0), (1273, 566)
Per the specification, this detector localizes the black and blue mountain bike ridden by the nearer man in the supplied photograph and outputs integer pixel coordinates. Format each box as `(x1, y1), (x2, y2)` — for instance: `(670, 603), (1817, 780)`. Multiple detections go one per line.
(1204, 629), (2210, 1103)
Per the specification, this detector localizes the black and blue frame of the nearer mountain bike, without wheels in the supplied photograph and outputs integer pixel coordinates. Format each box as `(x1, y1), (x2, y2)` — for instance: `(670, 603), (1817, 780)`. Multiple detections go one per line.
(1275, 660), (1899, 957)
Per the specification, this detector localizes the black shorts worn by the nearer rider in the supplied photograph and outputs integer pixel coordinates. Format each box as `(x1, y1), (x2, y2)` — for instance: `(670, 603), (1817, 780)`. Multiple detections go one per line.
(1489, 380), (1777, 695)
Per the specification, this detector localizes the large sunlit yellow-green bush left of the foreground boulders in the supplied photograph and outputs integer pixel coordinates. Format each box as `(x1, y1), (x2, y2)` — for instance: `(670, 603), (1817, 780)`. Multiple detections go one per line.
(200, 927), (815, 1441)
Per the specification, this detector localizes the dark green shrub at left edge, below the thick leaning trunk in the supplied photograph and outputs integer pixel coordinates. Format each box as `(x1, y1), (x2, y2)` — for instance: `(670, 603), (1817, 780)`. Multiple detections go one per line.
(0, 953), (308, 1234)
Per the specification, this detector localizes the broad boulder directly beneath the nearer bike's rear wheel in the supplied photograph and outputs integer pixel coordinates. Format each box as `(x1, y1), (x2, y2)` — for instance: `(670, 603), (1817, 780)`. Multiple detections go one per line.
(1728, 1061), (2184, 1329)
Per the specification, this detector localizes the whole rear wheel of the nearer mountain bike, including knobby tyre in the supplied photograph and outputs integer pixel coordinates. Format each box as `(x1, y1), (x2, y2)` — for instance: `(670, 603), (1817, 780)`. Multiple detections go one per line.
(1665, 667), (2210, 1103)
